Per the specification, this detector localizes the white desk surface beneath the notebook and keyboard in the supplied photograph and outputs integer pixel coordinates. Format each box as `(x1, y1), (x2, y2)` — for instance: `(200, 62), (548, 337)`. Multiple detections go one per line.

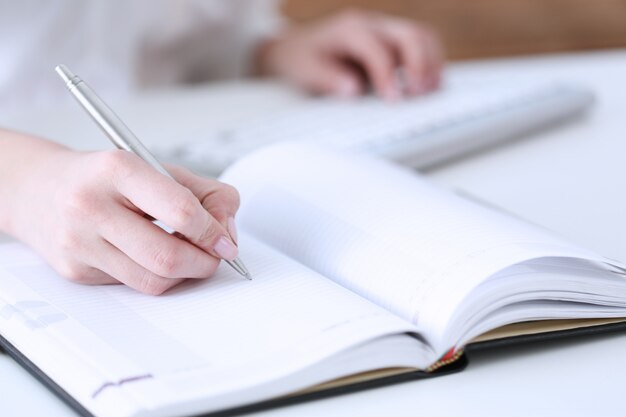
(0, 50), (626, 417)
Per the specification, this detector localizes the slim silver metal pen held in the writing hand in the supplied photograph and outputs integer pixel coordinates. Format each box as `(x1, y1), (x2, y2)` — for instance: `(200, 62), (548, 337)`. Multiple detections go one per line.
(55, 64), (252, 279)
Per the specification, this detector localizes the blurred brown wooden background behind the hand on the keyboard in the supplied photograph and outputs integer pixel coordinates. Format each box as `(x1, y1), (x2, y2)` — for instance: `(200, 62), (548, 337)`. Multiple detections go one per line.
(283, 0), (626, 59)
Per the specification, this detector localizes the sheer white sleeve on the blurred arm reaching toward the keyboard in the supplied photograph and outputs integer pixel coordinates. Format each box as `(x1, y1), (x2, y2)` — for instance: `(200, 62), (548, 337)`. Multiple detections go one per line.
(137, 0), (282, 86)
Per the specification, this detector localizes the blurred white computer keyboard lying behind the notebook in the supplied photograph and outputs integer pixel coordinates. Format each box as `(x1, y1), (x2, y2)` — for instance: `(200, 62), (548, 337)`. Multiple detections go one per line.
(154, 82), (594, 175)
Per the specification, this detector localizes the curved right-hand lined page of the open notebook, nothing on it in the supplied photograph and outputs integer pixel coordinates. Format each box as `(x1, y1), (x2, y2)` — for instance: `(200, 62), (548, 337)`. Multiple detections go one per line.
(222, 144), (600, 348)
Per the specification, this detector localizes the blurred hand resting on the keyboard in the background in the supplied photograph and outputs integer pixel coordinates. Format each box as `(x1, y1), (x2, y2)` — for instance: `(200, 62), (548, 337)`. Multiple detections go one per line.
(257, 11), (443, 100)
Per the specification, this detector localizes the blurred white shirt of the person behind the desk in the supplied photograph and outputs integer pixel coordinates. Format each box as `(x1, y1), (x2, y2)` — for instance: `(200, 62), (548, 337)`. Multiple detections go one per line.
(0, 0), (280, 112)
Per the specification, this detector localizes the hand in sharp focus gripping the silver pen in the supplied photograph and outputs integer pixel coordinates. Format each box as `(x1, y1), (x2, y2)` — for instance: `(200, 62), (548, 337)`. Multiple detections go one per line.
(7, 135), (239, 295)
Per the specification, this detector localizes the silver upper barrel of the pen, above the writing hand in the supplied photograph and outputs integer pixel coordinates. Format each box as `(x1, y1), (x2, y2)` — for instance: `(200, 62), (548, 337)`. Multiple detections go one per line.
(68, 77), (172, 178)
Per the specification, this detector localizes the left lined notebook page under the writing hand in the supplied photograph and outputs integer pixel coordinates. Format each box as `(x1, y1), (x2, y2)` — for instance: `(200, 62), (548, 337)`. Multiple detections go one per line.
(0, 233), (415, 416)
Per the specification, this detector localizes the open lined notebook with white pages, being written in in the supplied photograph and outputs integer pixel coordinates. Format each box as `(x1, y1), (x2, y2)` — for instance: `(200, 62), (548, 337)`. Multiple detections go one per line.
(0, 144), (626, 417)
